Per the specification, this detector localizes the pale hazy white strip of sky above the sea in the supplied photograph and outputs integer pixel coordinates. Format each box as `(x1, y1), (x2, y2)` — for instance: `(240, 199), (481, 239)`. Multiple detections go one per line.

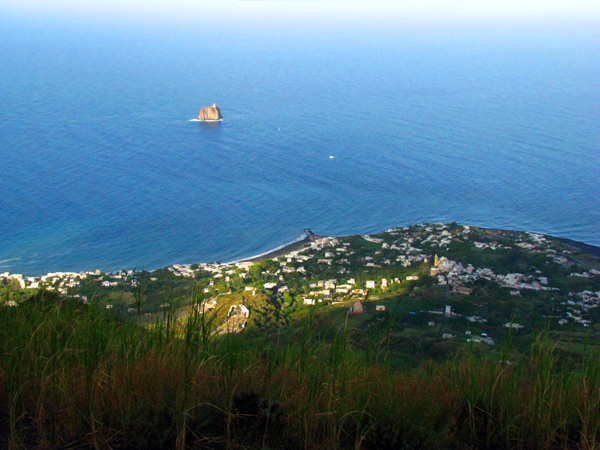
(0, 0), (600, 26)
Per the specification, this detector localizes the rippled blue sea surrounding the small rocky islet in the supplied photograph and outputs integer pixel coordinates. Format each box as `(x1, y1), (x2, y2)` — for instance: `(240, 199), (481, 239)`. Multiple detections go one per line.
(0, 18), (600, 275)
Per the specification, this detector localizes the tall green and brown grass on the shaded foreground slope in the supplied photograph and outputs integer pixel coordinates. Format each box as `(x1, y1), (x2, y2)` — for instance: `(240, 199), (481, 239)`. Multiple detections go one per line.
(0, 297), (600, 449)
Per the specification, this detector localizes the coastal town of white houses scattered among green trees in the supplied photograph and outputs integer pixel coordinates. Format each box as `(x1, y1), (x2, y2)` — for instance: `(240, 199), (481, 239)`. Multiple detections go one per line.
(0, 223), (600, 345)
